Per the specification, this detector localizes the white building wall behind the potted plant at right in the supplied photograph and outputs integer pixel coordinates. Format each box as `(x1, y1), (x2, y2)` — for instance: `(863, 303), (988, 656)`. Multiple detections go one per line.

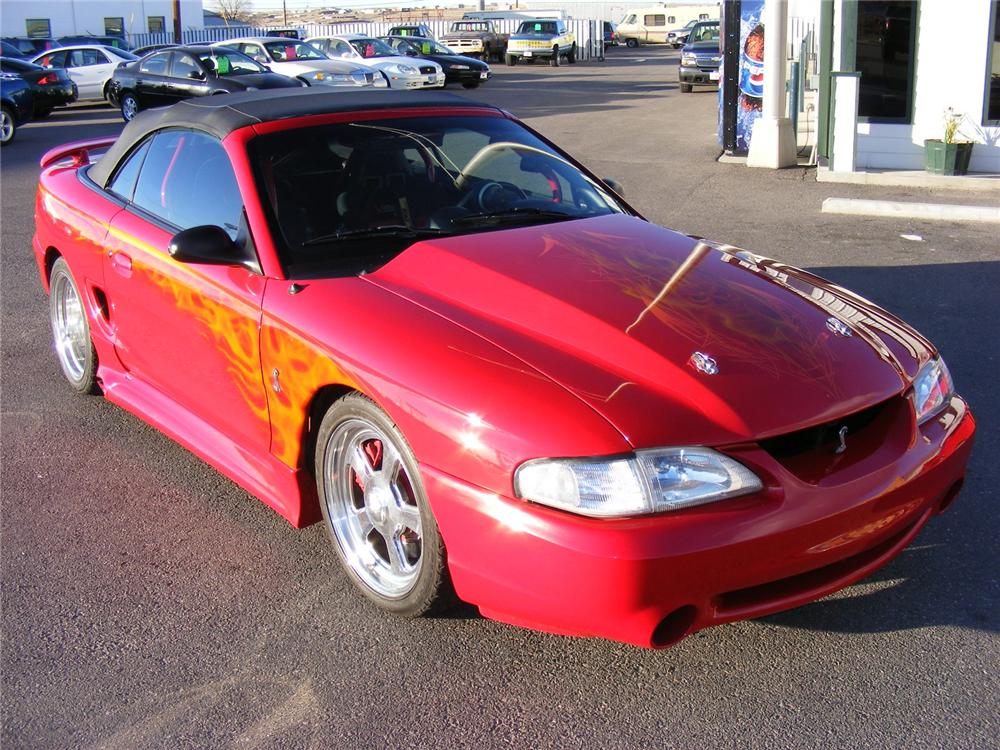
(852, 0), (1000, 172)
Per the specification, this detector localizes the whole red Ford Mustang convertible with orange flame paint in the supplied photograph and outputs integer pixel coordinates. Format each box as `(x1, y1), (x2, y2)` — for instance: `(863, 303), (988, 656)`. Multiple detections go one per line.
(34, 89), (975, 647)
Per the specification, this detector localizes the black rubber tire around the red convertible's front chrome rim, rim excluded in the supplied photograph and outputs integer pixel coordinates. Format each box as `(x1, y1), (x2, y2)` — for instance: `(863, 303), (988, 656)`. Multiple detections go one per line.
(313, 393), (454, 617)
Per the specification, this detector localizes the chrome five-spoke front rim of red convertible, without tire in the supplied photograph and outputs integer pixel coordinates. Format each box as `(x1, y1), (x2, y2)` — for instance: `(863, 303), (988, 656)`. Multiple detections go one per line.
(321, 418), (424, 599)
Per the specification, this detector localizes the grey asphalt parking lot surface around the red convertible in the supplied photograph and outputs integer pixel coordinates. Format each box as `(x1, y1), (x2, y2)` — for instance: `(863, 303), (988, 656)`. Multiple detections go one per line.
(0, 48), (1000, 749)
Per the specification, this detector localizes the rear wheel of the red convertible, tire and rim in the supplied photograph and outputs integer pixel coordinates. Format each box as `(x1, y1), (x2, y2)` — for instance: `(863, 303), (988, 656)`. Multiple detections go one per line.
(49, 258), (100, 394)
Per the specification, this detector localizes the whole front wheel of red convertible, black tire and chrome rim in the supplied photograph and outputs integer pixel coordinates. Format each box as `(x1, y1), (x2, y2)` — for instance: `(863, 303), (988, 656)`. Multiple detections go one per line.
(315, 393), (455, 617)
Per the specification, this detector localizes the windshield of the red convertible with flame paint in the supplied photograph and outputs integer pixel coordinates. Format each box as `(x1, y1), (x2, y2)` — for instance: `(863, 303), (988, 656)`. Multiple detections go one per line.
(249, 116), (628, 278)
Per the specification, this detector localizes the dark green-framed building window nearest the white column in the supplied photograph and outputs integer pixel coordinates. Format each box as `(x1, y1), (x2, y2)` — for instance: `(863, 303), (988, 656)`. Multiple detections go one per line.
(855, 0), (917, 122)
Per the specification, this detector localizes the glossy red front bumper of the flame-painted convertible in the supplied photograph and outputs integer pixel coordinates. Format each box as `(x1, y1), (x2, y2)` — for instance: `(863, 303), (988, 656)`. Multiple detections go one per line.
(422, 397), (975, 648)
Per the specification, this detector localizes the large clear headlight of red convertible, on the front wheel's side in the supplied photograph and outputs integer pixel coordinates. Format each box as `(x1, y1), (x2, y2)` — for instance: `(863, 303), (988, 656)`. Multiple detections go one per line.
(514, 447), (763, 518)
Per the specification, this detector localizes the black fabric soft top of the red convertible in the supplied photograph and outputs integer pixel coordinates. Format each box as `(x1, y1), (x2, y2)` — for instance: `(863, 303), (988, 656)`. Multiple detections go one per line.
(88, 87), (497, 187)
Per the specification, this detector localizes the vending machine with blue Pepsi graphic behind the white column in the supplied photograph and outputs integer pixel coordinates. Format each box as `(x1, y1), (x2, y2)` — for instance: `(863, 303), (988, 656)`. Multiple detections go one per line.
(719, 0), (765, 156)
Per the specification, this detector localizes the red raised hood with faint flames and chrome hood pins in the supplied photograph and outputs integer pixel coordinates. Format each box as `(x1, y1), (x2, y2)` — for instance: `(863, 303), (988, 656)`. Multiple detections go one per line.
(365, 215), (933, 447)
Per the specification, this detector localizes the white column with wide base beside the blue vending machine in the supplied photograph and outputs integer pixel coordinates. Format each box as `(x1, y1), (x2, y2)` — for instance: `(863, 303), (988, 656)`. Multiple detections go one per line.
(747, 0), (797, 169)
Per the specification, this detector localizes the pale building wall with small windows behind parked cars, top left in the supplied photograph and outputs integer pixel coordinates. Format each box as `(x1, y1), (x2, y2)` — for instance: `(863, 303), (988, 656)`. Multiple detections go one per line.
(0, 0), (205, 37)
